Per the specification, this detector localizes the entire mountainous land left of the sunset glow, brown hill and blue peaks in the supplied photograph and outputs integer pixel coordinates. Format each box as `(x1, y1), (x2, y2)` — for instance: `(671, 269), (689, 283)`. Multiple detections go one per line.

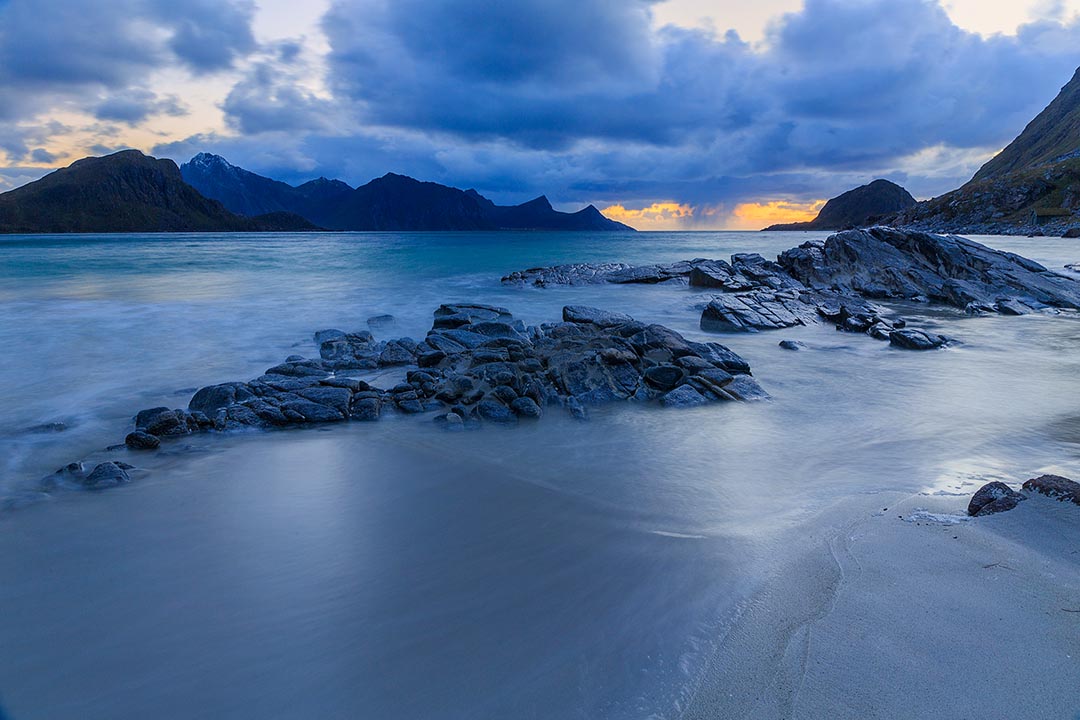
(0, 150), (634, 233)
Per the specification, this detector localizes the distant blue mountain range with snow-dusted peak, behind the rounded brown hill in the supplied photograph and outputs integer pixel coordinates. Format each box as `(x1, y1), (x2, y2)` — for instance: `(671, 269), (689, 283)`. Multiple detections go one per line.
(180, 152), (633, 231)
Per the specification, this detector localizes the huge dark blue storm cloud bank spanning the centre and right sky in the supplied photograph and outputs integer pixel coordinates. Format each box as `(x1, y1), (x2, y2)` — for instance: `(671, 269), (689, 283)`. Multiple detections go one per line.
(315, 0), (1080, 173)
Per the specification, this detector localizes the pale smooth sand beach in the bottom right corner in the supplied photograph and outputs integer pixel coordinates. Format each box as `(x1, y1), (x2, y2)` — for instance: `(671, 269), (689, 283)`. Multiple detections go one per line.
(679, 493), (1080, 720)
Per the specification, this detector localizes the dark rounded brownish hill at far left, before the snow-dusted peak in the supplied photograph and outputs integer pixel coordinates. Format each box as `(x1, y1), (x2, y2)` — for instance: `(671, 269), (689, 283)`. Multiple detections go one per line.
(0, 150), (313, 233)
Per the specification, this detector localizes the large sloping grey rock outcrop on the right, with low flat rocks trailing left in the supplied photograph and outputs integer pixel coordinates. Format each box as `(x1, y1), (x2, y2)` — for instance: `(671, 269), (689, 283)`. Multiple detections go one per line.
(502, 228), (1080, 350)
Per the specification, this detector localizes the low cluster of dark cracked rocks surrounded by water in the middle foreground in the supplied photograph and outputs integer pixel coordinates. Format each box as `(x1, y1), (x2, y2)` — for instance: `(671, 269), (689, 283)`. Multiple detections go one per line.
(111, 304), (768, 449)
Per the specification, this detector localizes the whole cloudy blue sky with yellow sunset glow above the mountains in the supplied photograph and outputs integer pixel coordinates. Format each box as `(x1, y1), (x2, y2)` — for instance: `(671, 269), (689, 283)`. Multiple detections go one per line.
(0, 0), (1080, 229)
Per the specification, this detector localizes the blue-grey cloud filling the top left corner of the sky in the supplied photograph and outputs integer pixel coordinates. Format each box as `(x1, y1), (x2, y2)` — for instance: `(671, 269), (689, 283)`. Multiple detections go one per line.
(0, 0), (256, 162)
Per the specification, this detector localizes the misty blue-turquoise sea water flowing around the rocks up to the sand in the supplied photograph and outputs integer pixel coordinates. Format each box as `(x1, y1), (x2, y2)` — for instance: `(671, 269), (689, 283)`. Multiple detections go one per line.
(0, 233), (1080, 719)
